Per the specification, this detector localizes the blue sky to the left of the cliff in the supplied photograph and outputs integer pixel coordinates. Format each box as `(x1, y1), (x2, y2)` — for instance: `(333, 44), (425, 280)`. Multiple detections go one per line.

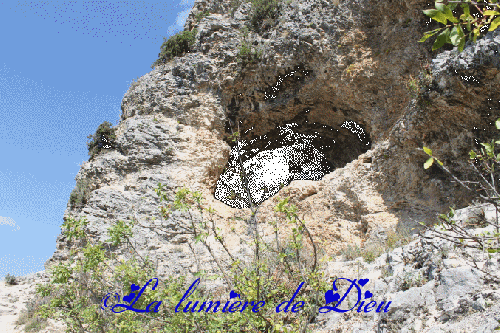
(0, 0), (194, 278)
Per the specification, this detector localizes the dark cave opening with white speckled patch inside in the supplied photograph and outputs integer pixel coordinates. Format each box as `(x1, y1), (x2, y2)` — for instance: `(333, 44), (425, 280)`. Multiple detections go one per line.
(214, 120), (371, 208)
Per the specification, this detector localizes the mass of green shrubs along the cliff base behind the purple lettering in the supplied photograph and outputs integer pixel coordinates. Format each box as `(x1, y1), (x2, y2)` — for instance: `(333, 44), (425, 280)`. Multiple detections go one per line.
(33, 124), (328, 333)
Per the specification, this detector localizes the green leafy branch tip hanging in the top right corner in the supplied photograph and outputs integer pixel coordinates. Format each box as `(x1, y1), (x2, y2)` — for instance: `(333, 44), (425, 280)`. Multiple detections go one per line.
(420, 0), (500, 52)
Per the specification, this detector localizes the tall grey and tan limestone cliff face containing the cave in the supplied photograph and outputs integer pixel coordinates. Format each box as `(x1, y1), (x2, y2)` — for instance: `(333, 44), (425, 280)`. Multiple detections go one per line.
(46, 0), (500, 314)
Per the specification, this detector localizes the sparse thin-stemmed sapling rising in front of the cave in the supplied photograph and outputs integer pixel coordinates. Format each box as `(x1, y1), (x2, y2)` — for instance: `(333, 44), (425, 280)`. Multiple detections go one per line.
(152, 119), (328, 333)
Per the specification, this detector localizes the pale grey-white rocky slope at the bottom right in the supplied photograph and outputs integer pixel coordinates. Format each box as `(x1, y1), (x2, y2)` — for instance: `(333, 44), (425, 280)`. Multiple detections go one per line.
(317, 206), (500, 333)
